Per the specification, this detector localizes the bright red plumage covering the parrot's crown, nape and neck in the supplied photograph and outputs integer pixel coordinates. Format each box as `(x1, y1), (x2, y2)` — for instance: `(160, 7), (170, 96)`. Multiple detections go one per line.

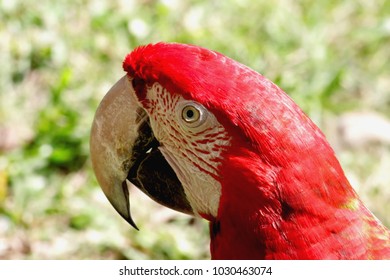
(123, 43), (390, 259)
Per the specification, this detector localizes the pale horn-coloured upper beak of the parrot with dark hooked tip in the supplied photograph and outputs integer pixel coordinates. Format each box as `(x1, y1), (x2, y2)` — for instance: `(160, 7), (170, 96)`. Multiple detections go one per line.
(90, 76), (139, 229)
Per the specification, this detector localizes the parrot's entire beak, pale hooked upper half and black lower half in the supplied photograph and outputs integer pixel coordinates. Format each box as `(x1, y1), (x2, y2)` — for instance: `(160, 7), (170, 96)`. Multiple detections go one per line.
(90, 76), (193, 229)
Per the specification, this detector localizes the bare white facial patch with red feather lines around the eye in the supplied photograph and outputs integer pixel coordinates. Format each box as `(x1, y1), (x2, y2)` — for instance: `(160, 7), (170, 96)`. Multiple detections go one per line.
(143, 83), (231, 217)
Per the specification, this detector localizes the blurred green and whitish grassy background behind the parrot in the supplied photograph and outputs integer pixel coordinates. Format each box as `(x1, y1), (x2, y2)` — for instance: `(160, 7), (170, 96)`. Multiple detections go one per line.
(0, 0), (390, 259)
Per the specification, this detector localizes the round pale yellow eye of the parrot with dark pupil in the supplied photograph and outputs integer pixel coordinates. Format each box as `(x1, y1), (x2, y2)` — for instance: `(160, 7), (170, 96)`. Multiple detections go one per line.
(179, 101), (208, 128)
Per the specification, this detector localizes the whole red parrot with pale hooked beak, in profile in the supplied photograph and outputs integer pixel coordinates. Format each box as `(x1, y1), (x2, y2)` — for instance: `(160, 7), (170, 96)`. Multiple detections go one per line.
(90, 43), (390, 259)
